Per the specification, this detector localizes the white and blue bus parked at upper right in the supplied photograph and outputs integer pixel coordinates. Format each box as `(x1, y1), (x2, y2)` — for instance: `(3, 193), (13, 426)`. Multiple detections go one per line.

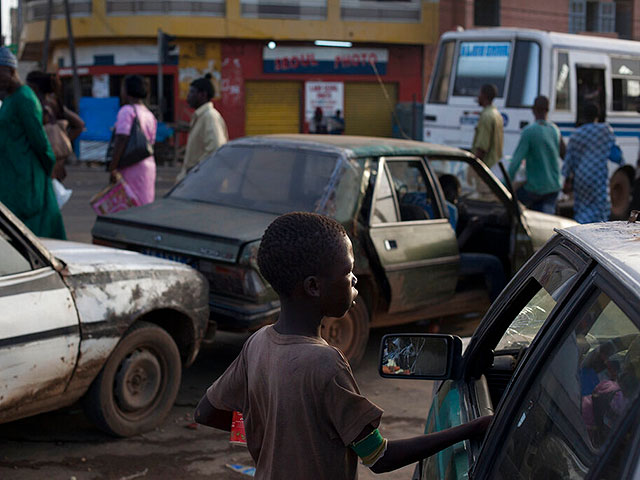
(423, 28), (640, 174)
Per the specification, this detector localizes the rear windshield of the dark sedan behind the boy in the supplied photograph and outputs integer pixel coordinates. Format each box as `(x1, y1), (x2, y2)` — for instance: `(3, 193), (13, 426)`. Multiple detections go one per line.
(168, 145), (340, 214)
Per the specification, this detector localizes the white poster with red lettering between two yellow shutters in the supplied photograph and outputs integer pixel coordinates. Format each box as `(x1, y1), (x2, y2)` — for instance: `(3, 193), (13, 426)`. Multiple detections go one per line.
(304, 82), (344, 133)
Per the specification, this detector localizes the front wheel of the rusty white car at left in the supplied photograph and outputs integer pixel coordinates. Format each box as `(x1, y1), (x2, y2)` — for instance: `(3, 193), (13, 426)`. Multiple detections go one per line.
(83, 322), (182, 437)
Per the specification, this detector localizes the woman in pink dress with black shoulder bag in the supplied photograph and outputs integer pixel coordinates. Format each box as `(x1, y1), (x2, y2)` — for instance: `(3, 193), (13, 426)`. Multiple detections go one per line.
(109, 75), (158, 205)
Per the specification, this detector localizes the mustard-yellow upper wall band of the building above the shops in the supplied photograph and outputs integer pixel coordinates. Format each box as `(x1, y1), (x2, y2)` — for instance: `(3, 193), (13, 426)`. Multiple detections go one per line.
(22, 0), (438, 45)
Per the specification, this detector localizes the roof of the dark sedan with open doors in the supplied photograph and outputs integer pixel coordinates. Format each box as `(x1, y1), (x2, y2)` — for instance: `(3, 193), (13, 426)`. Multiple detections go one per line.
(228, 134), (471, 157)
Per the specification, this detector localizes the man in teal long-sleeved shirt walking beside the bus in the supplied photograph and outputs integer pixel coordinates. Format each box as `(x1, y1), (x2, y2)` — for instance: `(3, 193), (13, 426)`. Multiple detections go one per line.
(509, 96), (564, 214)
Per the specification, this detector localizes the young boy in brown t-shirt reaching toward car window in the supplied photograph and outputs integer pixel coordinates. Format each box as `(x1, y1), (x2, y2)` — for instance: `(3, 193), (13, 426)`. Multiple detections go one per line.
(195, 212), (490, 480)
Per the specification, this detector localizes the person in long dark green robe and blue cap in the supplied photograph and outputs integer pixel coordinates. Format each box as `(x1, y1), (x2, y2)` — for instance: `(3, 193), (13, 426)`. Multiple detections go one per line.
(0, 46), (66, 239)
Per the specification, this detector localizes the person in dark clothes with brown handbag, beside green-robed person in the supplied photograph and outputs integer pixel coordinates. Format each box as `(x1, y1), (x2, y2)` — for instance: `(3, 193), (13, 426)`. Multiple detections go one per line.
(26, 70), (85, 181)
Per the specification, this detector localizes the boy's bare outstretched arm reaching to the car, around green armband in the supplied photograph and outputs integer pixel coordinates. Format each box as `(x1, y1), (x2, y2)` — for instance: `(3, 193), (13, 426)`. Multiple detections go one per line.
(354, 416), (493, 473)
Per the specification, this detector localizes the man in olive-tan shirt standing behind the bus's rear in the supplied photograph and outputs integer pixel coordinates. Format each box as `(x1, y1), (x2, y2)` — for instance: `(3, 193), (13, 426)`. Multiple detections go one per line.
(471, 84), (504, 168)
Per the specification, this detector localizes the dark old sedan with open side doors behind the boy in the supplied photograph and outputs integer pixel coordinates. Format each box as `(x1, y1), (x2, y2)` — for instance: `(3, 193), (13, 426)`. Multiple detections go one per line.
(92, 135), (573, 363)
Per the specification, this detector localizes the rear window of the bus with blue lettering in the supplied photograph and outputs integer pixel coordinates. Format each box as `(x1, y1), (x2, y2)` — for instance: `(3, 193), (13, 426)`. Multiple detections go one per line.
(453, 42), (511, 97)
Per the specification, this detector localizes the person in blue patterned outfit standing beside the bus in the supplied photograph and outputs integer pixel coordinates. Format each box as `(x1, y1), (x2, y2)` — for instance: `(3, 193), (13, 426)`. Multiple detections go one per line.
(562, 103), (622, 223)
